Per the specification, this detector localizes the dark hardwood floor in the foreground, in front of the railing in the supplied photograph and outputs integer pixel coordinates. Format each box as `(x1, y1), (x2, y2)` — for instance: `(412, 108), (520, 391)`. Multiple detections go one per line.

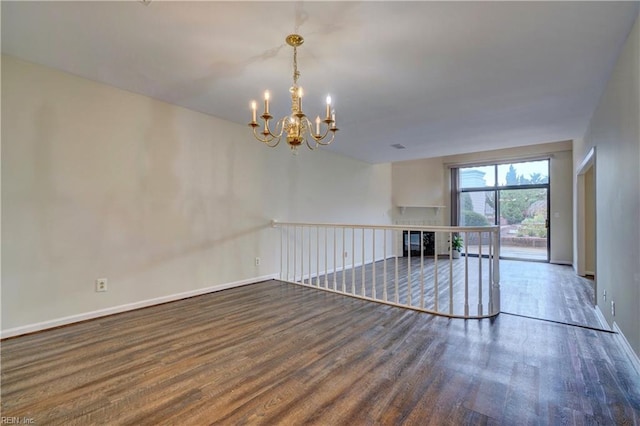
(0, 263), (640, 425)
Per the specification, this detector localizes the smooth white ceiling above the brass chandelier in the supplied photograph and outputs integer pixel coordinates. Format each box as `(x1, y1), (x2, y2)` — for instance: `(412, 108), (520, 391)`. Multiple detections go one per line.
(2, 0), (639, 163)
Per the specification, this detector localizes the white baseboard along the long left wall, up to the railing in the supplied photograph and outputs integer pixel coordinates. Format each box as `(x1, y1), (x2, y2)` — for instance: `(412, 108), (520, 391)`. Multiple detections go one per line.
(0, 274), (277, 339)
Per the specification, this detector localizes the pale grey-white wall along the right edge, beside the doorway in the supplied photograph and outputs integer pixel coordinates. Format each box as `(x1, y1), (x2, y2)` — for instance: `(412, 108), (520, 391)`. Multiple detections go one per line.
(574, 15), (640, 354)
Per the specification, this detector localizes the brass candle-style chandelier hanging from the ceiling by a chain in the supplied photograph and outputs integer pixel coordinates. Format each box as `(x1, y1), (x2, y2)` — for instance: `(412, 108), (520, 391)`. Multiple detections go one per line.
(249, 34), (338, 153)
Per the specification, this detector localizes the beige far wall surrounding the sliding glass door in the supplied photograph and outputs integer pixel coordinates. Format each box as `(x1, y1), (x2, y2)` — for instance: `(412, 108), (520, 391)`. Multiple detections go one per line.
(392, 141), (573, 264)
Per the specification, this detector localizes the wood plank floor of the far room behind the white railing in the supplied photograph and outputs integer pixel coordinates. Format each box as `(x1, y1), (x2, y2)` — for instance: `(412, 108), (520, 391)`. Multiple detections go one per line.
(296, 257), (601, 328)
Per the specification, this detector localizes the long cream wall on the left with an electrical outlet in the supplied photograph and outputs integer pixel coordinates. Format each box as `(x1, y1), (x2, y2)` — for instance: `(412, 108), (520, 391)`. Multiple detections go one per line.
(1, 56), (391, 336)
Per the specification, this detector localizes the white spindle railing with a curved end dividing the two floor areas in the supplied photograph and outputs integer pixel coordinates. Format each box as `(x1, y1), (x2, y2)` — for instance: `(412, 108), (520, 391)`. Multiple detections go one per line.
(273, 221), (500, 318)
